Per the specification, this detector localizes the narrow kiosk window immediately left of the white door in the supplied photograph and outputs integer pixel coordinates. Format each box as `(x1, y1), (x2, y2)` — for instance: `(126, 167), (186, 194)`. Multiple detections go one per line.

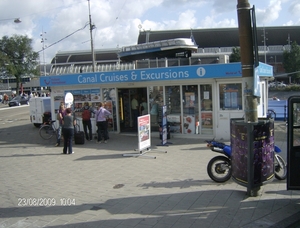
(199, 84), (213, 135)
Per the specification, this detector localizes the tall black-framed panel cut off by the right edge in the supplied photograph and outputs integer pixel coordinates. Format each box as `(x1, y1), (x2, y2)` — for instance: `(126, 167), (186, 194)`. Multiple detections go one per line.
(287, 96), (300, 190)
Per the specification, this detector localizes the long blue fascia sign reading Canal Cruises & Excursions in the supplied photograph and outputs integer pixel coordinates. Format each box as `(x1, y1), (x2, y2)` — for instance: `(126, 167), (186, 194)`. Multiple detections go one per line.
(40, 63), (273, 87)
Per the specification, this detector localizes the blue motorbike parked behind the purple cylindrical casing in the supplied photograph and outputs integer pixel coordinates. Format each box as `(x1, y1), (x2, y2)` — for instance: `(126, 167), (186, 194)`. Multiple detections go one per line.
(206, 140), (287, 183)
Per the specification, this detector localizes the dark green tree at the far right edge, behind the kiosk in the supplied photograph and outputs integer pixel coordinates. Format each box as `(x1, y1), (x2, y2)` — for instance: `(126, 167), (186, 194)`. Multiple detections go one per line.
(283, 41), (300, 82)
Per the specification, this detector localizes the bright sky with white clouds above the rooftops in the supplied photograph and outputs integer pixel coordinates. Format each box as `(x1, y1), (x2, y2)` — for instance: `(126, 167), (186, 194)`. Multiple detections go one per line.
(0, 0), (300, 63)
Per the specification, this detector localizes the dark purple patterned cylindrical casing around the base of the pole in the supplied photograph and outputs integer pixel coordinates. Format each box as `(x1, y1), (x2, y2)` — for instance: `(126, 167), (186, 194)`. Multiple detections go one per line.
(230, 118), (274, 189)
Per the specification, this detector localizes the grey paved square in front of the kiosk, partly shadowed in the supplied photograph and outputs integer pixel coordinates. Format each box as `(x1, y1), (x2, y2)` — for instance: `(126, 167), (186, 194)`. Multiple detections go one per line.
(0, 104), (300, 228)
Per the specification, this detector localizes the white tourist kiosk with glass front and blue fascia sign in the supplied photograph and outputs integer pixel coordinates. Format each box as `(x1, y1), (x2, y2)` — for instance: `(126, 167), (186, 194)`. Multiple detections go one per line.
(40, 63), (273, 140)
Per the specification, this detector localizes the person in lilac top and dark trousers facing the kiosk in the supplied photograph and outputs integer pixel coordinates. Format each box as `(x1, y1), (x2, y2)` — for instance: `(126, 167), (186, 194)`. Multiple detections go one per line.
(96, 102), (111, 143)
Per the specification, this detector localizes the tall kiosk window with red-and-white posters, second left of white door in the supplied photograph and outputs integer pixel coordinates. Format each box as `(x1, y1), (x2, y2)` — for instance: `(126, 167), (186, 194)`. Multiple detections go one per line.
(182, 85), (199, 134)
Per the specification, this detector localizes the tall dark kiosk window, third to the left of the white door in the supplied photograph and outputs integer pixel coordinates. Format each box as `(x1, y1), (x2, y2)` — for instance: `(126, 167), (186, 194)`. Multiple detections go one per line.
(165, 86), (181, 133)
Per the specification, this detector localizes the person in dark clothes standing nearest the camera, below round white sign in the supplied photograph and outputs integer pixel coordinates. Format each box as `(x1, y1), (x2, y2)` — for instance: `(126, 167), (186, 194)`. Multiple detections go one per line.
(62, 108), (76, 154)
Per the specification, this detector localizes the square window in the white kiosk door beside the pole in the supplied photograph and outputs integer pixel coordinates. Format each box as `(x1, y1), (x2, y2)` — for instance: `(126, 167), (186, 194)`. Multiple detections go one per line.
(219, 83), (243, 110)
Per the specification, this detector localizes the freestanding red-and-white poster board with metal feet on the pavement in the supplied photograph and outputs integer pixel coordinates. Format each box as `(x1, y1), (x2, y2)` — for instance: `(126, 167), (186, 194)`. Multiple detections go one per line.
(123, 114), (167, 159)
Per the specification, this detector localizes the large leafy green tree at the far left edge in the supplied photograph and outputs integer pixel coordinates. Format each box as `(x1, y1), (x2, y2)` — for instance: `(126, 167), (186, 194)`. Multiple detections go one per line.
(0, 35), (39, 92)
